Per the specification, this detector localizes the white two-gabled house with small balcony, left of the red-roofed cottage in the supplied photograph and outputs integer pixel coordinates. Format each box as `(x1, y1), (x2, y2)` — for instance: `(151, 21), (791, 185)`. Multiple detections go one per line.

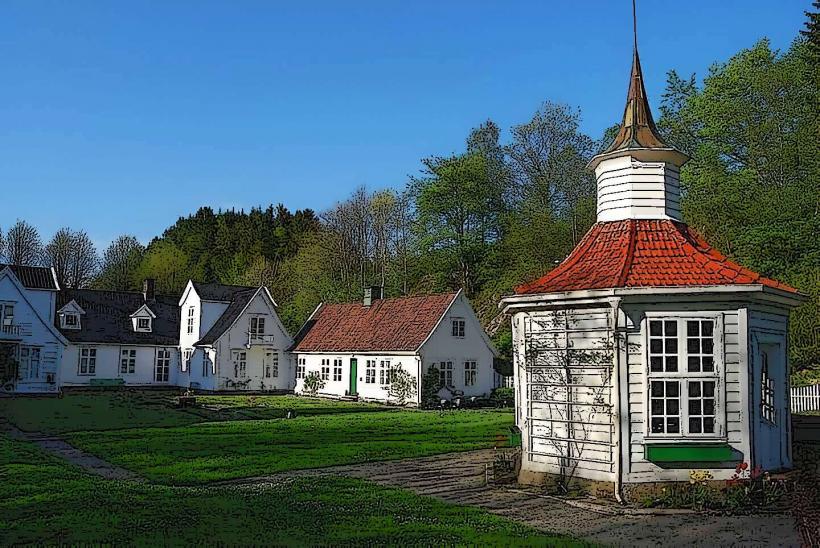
(178, 281), (294, 391)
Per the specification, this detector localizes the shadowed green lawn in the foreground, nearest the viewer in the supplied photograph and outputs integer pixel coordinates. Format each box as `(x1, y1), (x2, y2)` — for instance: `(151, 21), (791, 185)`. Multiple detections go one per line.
(0, 435), (582, 546)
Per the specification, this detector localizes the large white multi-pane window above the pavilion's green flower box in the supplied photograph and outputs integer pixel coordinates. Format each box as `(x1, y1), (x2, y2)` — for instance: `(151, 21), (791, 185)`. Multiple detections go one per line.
(648, 319), (720, 437)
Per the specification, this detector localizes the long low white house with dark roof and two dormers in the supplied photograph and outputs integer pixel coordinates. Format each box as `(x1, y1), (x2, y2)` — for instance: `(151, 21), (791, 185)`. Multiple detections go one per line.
(55, 280), (180, 387)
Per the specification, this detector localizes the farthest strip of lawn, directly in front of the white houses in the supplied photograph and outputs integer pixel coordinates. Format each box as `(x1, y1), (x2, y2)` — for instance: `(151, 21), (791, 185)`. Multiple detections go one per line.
(0, 390), (384, 434)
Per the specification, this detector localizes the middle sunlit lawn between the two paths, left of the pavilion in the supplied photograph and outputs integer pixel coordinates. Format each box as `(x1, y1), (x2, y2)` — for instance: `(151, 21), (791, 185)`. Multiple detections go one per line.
(68, 410), (513, 485)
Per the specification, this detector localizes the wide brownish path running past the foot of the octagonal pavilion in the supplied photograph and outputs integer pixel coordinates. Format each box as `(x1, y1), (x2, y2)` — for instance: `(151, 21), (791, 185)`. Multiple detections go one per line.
(224, 450), (800, 547)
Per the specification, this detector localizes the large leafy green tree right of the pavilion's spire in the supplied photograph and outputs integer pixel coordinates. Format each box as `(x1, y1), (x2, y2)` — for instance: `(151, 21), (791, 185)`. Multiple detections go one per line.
(660, 40), (820, 370)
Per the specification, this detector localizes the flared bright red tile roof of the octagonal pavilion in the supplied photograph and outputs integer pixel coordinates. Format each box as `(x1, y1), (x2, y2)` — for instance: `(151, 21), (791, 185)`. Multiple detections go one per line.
(516, 219), (797, 294)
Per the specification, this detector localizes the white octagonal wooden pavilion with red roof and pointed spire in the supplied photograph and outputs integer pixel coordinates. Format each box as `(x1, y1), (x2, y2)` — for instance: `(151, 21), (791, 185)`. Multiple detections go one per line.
(502, 44), (802, 498)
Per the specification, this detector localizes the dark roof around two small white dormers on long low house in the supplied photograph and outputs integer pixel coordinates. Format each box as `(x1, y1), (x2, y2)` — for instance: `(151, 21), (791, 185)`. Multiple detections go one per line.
(55, 289), (179, 346)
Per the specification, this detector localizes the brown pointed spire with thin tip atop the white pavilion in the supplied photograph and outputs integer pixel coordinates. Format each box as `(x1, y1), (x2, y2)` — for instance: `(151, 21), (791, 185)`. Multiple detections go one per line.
(604, 0), (670, 154)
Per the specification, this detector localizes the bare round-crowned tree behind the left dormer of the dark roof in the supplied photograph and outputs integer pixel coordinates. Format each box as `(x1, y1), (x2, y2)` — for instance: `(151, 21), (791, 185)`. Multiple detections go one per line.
(44, 228), (99, 288)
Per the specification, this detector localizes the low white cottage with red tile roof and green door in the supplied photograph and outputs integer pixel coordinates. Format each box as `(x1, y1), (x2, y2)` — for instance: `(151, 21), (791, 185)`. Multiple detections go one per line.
(293, 288), (497, 404)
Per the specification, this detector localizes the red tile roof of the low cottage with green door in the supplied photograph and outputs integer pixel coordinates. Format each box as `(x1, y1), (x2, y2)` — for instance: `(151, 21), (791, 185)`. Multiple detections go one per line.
(293, 293), (458, 352)
